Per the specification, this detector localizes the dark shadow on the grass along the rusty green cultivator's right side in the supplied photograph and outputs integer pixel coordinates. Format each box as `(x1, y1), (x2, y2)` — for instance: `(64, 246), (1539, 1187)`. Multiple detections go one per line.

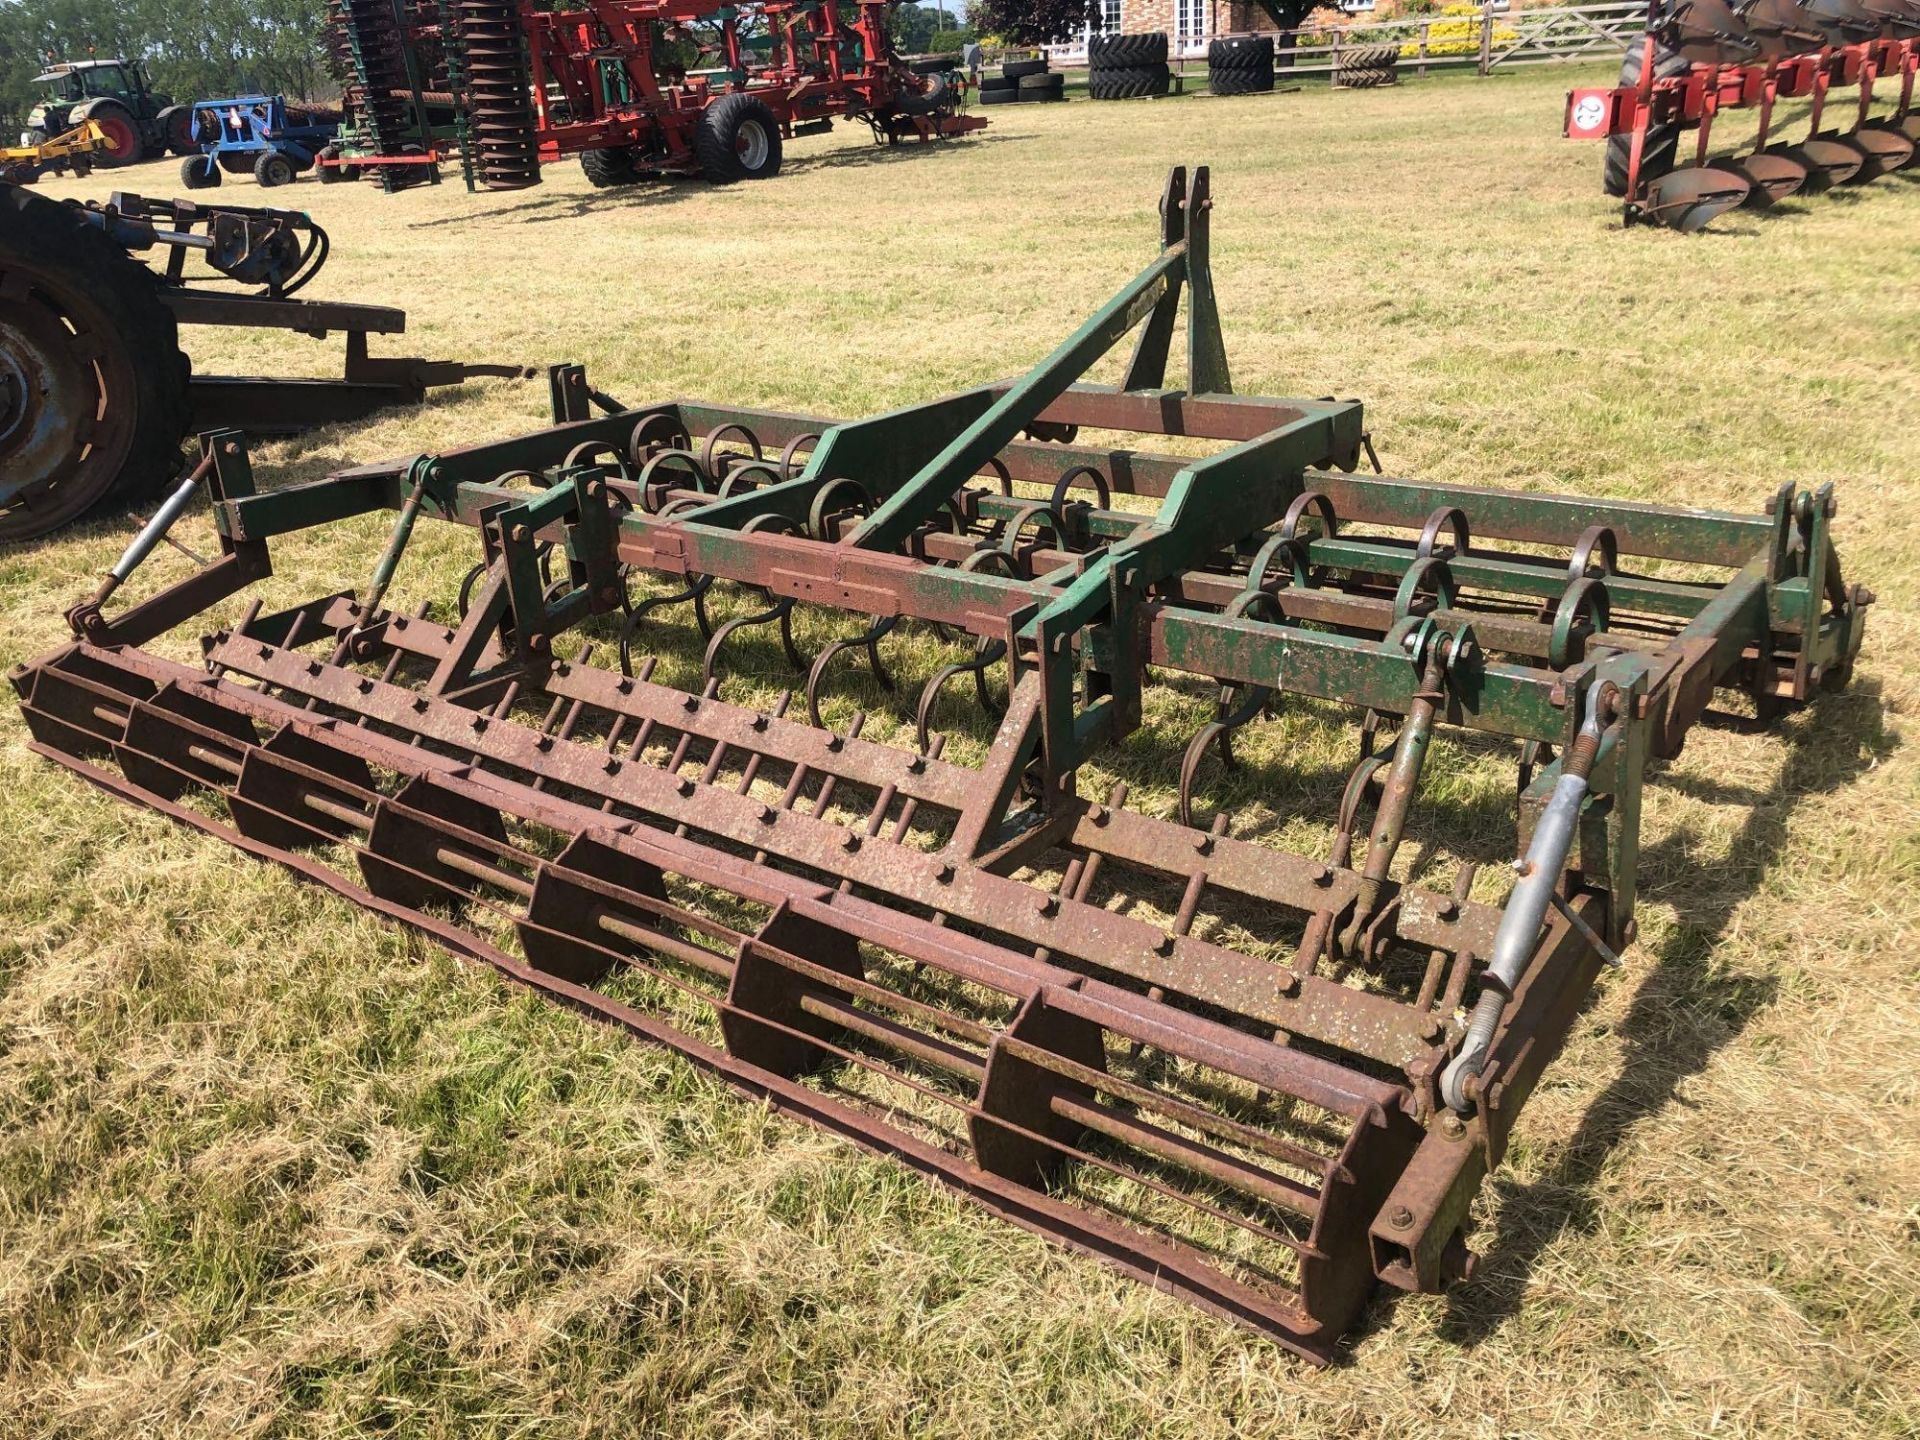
(1420, 680), (1899, 1346)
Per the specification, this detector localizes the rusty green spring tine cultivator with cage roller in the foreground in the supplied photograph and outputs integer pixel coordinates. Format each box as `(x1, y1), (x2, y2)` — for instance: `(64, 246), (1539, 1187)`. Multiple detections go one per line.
(13, 169), (1872, 1361)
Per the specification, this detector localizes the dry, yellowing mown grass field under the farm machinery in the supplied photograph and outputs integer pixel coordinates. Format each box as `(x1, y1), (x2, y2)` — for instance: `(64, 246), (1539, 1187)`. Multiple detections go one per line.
(0, 71), (1920, 1440)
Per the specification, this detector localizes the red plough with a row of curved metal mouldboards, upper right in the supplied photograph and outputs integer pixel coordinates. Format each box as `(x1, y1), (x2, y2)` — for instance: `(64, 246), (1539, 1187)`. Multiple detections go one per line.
(1565, 0), (1920, 230)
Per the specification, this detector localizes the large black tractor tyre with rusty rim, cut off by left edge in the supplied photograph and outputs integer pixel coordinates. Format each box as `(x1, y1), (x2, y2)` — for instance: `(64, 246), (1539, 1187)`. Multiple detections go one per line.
(0, 188), (188, 541)
